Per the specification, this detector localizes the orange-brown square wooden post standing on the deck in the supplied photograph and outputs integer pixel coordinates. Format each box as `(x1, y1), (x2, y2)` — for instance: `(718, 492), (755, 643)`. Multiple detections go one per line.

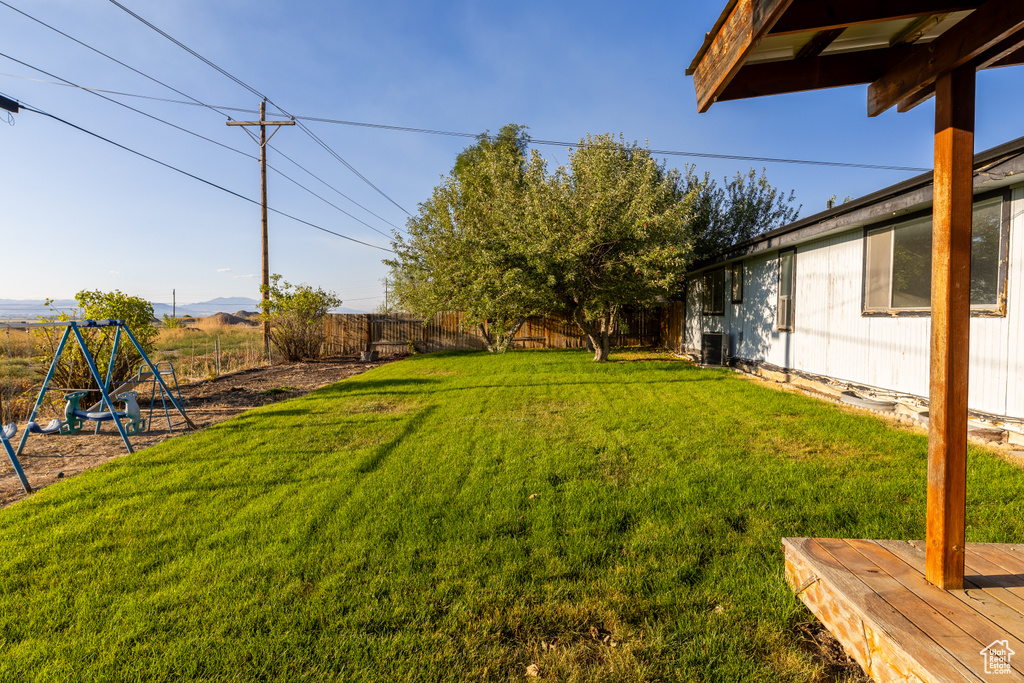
(926, 66), (975, 590)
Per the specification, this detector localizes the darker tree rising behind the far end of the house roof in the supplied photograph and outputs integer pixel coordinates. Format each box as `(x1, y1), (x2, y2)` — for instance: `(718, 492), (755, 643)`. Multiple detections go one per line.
(686, 166), (800, 260)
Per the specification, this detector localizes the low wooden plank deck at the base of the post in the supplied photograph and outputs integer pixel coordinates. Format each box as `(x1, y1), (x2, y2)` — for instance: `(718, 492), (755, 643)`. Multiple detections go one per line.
(782, 539), (1024, 683)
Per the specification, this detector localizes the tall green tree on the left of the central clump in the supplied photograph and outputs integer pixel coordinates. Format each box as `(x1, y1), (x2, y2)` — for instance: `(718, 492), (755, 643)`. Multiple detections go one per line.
(385, 124), (551, 352)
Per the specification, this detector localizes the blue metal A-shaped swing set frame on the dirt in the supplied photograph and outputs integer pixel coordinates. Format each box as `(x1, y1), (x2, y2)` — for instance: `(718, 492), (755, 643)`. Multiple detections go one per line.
(0, 319), (194, 494)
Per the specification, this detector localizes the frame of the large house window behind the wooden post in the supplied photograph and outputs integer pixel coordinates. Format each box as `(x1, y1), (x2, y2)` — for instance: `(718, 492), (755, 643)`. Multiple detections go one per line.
(860, 188), (1013, 317)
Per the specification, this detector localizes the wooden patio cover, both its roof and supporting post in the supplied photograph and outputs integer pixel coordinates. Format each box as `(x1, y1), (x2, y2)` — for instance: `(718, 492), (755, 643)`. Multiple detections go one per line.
(687, 0), (1024, 590)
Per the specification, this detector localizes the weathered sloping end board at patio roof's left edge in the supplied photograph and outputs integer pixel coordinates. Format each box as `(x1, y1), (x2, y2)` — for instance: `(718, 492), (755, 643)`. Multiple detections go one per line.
(693, 0), (793, 113)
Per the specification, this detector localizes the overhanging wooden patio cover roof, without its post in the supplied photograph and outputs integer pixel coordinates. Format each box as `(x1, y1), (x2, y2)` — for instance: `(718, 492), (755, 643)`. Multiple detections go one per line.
(686, 0), (1024, 116)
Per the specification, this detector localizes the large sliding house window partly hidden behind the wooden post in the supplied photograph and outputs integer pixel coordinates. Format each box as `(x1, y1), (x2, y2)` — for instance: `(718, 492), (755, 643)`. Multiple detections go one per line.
(863, 196), (1007, 315)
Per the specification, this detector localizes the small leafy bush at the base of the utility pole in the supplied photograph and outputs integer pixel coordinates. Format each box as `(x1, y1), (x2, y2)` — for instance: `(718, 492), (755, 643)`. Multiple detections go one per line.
(260, 273), (341, 362)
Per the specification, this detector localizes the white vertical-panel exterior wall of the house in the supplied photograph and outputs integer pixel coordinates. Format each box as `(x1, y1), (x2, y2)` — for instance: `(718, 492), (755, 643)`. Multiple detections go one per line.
(686, 186), (1024, 419)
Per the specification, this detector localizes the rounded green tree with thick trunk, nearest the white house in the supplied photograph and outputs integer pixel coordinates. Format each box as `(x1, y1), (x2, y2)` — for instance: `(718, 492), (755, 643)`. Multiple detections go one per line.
(544, 134), (694, 360)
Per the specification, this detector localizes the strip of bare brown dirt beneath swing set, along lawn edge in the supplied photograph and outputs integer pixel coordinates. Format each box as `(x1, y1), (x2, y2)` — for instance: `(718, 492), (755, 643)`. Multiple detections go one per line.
(0, 357), (398, 507)
